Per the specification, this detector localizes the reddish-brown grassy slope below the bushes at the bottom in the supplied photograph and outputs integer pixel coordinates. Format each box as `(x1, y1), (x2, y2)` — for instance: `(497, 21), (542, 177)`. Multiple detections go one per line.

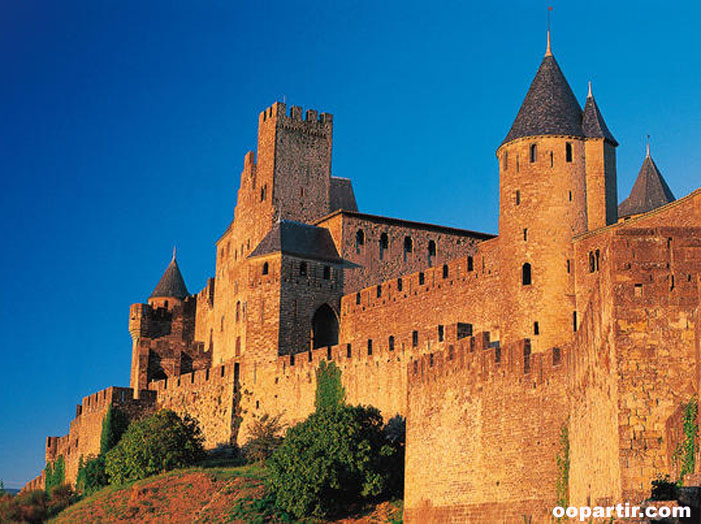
(52, 466), (401, 523)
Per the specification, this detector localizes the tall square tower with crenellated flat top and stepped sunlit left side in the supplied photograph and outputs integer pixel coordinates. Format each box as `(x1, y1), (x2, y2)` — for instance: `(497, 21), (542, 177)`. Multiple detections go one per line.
(205, 102), (333, 362)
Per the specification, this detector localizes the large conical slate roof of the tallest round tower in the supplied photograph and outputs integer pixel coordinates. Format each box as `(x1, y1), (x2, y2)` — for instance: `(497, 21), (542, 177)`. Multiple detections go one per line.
(502, 51), (584, 144)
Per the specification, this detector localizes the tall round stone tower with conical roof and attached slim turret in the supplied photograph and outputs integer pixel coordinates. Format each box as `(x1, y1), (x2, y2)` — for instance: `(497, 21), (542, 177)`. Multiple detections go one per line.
(497, 35), (616, 351)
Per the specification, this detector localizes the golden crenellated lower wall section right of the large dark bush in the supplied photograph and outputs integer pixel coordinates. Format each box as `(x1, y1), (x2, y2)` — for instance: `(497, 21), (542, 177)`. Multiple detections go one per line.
(404, 336), (568, 523)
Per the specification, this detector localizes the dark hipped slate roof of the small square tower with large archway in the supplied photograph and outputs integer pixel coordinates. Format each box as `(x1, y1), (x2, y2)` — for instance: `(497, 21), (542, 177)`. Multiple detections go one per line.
(248, 220), (341, 262)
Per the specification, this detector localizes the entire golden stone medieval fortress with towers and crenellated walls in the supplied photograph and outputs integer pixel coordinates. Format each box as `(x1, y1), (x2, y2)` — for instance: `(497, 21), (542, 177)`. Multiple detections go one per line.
(24, 33), (701, 522)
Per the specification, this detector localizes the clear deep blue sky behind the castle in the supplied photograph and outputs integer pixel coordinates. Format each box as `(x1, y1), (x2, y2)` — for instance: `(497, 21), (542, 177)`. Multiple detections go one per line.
(0, 0), (701, 487)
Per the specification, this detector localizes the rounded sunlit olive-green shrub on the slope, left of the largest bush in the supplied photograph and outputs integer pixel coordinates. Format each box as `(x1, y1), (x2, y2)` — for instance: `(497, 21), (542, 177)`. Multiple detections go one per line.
(105, 409), (204, 484)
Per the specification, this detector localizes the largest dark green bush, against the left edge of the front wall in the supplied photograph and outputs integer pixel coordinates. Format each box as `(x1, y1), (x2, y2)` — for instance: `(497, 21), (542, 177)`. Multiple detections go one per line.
(267, 406), (403, 518)
